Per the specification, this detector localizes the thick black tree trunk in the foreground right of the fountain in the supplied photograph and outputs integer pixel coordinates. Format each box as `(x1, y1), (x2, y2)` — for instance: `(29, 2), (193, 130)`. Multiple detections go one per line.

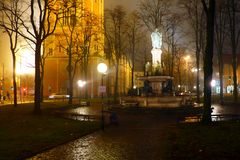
(201, 0), (216, 123)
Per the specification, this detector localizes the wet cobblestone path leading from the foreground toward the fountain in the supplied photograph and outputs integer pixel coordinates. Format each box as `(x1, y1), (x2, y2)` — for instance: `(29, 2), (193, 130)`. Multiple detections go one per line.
(31, 110), (175, 160)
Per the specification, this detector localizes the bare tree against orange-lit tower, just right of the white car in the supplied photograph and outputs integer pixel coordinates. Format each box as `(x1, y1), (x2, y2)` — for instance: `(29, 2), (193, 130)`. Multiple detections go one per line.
(58, 0), (83, 104)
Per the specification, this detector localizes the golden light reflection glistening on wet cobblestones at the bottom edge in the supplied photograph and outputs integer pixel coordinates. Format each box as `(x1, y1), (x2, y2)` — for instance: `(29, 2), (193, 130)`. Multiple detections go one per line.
(32, 132), (123, 160)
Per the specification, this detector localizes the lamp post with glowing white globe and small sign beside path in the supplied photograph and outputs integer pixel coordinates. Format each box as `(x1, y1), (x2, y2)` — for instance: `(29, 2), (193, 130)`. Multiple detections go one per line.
(97, 63), (107, 131)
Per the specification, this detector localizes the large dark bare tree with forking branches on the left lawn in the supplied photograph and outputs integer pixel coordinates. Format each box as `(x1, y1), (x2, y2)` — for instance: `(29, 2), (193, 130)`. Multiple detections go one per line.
(8, 0), (60, 114)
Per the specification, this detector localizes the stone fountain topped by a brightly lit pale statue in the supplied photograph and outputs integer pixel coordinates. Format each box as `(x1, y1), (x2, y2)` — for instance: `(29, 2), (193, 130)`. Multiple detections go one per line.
(120, 29), (185, 107)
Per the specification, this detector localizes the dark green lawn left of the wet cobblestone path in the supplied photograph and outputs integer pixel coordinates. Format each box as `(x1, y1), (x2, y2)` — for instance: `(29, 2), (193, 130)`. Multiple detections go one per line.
(0, 103), (100, 160)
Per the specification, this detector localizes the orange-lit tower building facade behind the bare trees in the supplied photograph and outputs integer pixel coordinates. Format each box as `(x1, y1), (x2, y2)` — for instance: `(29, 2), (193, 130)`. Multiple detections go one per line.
(43, 0), (130, 98)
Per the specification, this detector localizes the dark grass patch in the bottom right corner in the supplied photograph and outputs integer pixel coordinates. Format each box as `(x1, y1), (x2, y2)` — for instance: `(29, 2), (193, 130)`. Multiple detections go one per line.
(165, 122), (240, 160)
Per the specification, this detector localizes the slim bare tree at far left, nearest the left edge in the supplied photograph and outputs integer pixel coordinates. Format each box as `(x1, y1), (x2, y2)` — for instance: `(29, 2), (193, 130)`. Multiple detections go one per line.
(0, 0), (21, 106)
